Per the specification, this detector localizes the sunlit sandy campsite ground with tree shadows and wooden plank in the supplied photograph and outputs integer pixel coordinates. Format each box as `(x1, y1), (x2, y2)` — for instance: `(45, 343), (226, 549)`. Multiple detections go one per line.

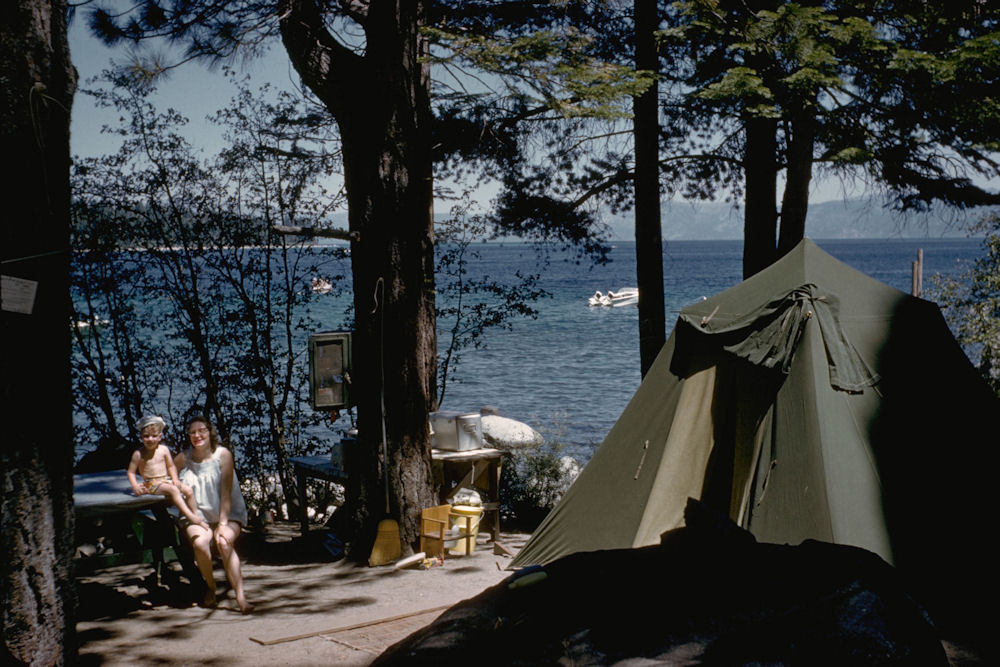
(77, 523), (527, 666)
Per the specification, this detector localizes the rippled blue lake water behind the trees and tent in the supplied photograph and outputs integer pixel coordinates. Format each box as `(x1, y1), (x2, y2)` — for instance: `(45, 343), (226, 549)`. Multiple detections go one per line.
(74, 238), (981, 461)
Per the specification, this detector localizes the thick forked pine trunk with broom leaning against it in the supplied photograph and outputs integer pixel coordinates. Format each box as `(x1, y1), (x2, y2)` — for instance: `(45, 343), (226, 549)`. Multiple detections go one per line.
(282, 0), (437, 560)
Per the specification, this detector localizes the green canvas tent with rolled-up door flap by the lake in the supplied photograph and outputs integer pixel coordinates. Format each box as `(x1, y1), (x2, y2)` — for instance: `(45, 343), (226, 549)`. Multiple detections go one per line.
(510, 239), (1000, 616)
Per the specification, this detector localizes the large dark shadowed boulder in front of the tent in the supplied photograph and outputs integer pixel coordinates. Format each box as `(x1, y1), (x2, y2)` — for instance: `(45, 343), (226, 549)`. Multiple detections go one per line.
(373, 504), (948, 665)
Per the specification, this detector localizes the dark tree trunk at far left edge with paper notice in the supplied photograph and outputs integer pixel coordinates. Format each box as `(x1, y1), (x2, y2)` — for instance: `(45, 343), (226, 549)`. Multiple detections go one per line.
(0, 0), (76, 665)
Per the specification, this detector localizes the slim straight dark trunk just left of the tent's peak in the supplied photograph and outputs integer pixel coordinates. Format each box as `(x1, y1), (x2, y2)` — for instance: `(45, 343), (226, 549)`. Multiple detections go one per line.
(633, 0), (667, 377)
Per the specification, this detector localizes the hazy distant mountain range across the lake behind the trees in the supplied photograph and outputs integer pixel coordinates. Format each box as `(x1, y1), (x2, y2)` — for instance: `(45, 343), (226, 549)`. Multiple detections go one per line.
(605, 199), (989, 241)
